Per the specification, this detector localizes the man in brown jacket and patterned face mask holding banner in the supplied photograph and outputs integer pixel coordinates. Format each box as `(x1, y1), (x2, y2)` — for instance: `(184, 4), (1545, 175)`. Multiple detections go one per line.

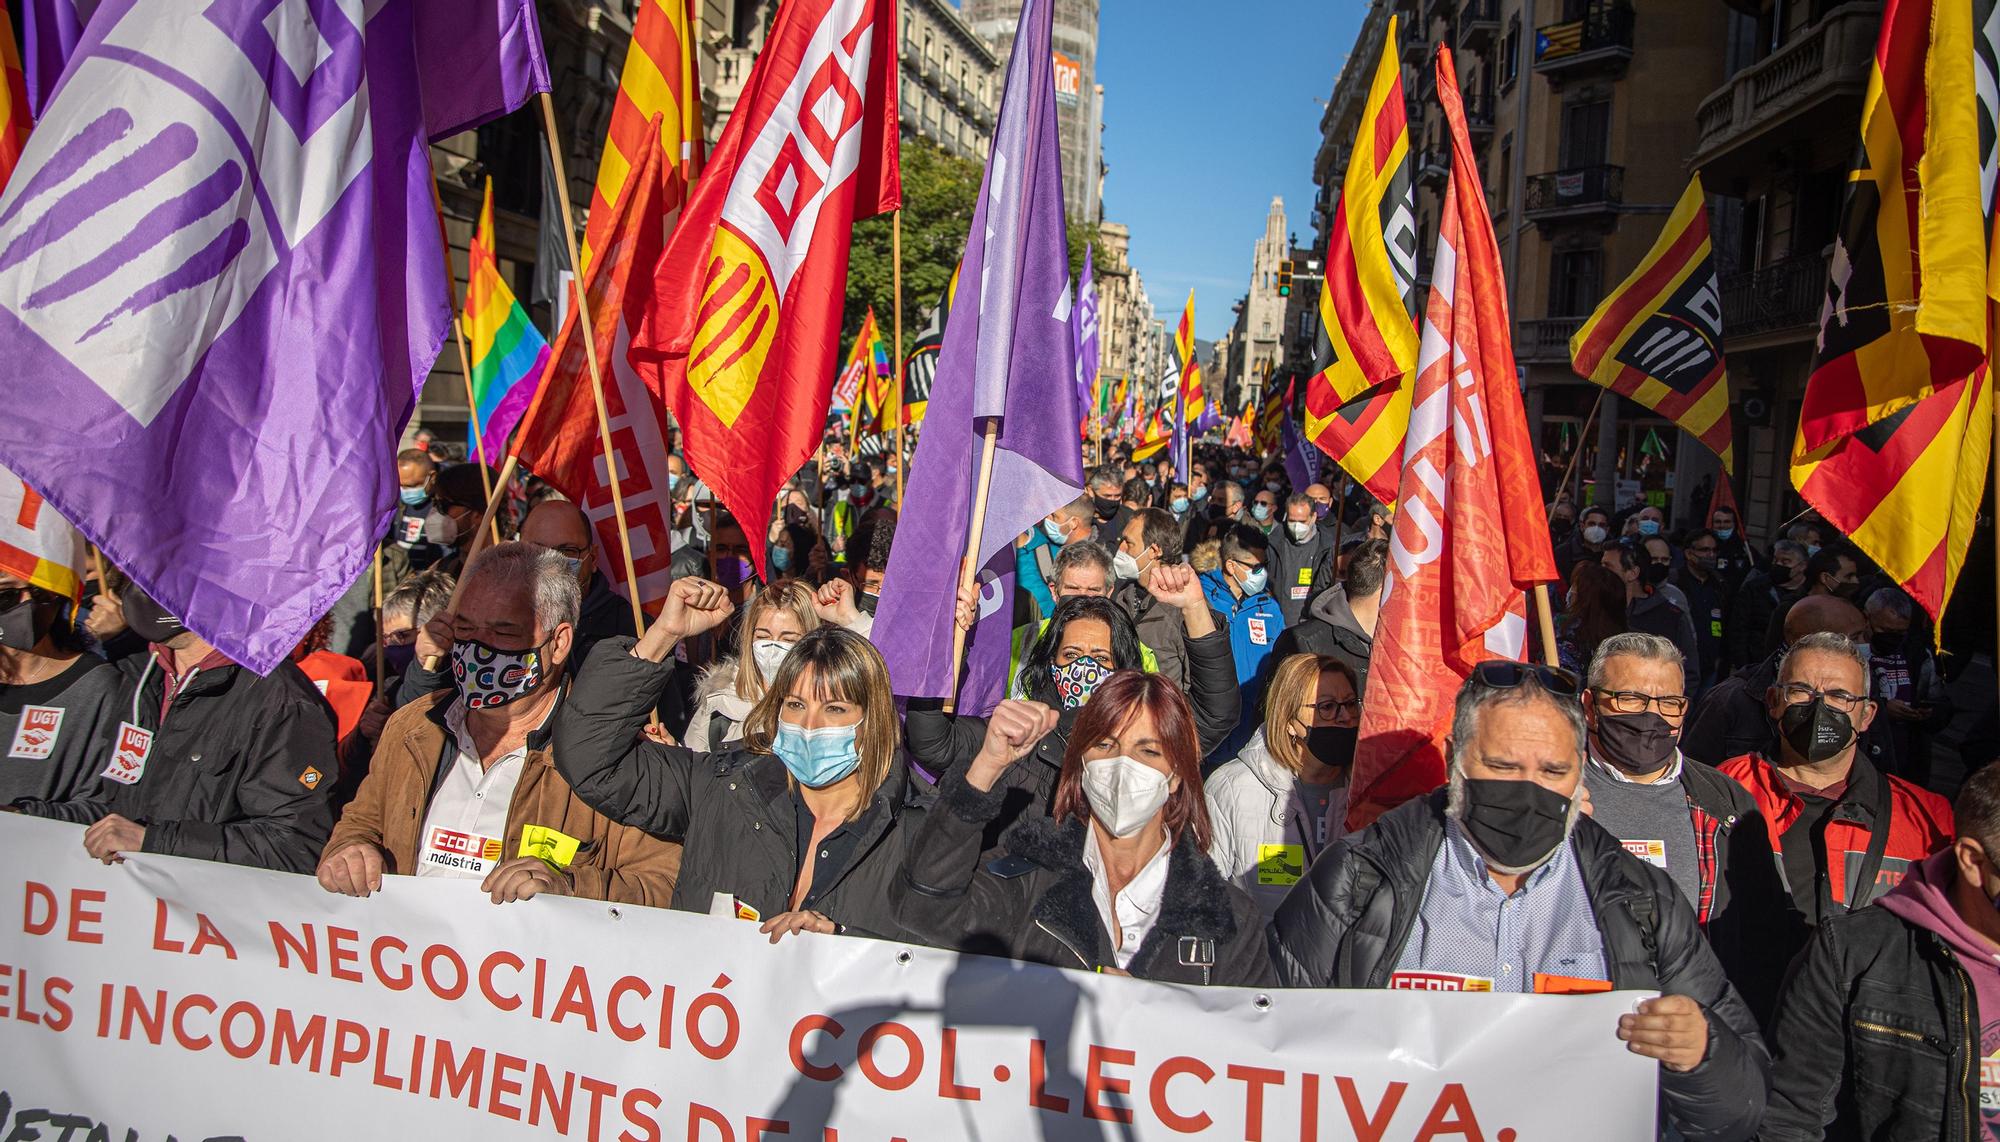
(318, 542), (680, 908)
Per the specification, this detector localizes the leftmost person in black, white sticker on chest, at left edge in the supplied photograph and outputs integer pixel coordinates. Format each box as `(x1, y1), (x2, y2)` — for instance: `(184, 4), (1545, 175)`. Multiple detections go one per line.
(0, 572), (122, 806)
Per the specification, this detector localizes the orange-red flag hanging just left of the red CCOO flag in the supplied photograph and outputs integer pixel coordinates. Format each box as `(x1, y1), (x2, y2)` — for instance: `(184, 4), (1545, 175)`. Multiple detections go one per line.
(514, 125), (674, 614)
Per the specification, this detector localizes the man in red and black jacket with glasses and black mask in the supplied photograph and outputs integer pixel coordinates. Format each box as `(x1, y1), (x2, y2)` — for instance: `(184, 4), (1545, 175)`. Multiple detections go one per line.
(1720, 634), (1952, 980)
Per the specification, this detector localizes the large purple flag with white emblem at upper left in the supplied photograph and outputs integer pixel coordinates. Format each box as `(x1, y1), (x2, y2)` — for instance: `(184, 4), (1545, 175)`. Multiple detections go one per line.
(0, 0), (548, 670)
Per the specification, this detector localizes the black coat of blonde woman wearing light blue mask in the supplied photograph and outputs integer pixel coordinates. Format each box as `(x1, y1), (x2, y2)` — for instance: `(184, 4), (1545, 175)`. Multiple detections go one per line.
(556, 638), (924, 938)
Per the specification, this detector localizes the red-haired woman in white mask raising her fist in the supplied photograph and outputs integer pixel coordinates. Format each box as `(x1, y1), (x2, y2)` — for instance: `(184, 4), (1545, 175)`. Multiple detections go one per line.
(890, 670), (1274, 986)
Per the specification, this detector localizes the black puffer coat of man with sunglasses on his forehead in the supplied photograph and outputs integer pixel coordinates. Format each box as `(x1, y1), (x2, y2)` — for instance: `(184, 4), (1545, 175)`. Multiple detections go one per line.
(1270, 790), (1770, 1142)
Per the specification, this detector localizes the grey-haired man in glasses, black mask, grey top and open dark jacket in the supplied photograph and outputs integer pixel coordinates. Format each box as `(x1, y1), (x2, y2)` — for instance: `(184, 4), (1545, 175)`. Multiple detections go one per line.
(1584, 634), (1784, 1016)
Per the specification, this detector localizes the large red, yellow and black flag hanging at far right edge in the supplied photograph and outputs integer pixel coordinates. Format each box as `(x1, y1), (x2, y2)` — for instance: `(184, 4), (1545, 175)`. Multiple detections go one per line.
(1792, 0), (2000, 620)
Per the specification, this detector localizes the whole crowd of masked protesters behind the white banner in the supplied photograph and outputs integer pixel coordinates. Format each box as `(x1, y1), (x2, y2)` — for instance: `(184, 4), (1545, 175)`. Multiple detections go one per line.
(0, 422), (2000, 1140)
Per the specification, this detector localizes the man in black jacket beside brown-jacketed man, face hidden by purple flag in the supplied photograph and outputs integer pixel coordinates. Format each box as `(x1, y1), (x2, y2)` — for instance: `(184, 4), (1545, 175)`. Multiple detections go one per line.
(16, 582), (340, 872)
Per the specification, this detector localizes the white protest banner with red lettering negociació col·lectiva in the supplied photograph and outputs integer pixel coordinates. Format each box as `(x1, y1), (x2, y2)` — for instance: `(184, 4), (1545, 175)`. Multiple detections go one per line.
(0, 816), (1658, 1142)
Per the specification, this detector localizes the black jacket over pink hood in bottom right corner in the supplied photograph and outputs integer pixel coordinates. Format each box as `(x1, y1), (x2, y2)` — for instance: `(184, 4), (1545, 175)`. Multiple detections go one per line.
(1758, 908), (1986, 1142)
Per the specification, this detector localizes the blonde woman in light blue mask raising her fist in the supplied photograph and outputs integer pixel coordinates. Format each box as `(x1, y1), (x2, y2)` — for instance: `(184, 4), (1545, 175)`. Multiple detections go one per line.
(556, 578), (922, 942)
